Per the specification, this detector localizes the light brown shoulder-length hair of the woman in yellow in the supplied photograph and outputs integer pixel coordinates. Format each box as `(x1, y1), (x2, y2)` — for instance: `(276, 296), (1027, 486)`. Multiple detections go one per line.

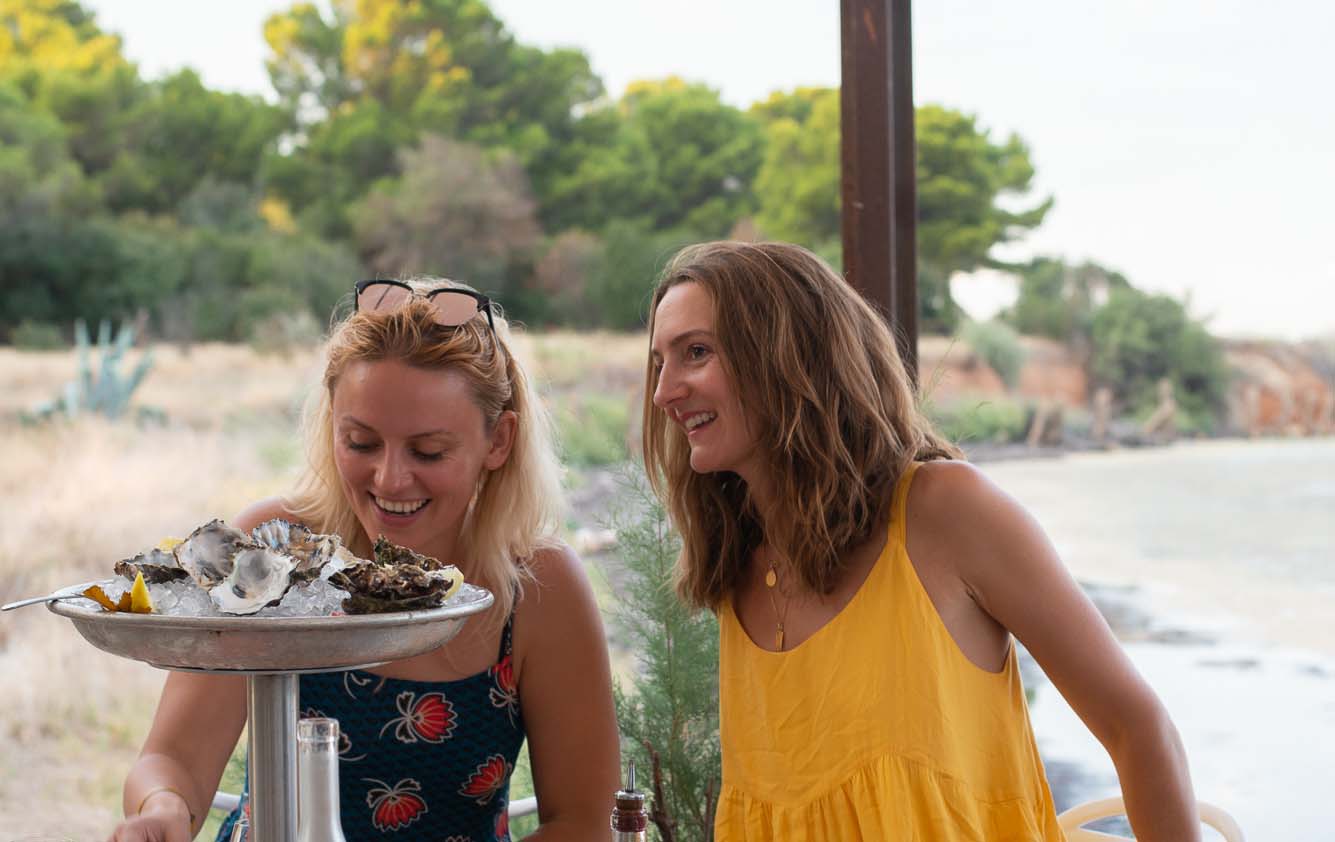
(643, 242), (964, 611)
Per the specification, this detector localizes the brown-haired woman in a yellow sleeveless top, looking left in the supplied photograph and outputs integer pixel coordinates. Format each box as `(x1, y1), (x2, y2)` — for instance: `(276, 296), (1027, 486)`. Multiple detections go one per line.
(643, 243), (1199, 842)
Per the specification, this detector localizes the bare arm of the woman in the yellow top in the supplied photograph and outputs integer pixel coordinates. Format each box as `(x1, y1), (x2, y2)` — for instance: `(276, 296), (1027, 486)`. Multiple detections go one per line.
(914, 463), (1200, 842)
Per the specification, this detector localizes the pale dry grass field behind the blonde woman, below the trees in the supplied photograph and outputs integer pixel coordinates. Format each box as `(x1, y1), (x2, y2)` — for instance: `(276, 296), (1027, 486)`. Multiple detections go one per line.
(0, 334), (645, 839)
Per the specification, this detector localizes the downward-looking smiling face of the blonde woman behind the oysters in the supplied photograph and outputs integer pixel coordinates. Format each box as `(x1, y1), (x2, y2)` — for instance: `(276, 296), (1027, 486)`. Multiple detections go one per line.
(332, 360), (515, 563)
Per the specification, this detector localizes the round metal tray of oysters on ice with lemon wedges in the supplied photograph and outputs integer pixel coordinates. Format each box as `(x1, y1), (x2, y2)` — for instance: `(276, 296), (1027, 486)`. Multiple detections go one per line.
(48, 520), (494, 674)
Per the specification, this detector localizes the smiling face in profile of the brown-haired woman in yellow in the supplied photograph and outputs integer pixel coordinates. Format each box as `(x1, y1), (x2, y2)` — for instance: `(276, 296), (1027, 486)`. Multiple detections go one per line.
(650, 283), (758, 484)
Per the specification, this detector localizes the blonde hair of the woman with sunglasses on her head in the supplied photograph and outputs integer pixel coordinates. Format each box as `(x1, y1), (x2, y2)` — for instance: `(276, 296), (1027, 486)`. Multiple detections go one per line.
(283, 278), (562, 618)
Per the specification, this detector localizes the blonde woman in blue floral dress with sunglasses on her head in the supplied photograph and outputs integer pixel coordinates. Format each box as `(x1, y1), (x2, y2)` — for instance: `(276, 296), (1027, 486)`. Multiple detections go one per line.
(111, 280), (618, 842)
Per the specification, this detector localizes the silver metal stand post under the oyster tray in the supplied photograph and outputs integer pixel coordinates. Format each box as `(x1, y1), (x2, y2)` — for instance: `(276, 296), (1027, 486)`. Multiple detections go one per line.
(246, 673), (298, 842)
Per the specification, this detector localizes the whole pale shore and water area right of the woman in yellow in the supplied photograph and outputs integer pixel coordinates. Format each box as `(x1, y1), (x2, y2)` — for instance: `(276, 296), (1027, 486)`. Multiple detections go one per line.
(980, 436), (1335, 839)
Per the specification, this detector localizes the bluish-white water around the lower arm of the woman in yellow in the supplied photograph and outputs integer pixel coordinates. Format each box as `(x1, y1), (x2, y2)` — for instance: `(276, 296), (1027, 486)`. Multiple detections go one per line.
(1020, 582), (1335, 839)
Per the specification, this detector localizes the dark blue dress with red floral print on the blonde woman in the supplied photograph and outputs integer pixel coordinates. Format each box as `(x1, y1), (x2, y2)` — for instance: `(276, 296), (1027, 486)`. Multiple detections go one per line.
(218, 614), (525, 842)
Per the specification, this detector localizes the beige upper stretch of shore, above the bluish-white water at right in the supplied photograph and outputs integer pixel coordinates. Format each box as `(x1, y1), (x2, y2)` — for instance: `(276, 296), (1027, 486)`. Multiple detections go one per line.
(980, 436), (1335, 658)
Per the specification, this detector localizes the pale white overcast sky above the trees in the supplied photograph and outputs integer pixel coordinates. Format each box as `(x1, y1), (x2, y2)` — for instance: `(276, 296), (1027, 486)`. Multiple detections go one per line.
(84, 0), (1335, 338)
